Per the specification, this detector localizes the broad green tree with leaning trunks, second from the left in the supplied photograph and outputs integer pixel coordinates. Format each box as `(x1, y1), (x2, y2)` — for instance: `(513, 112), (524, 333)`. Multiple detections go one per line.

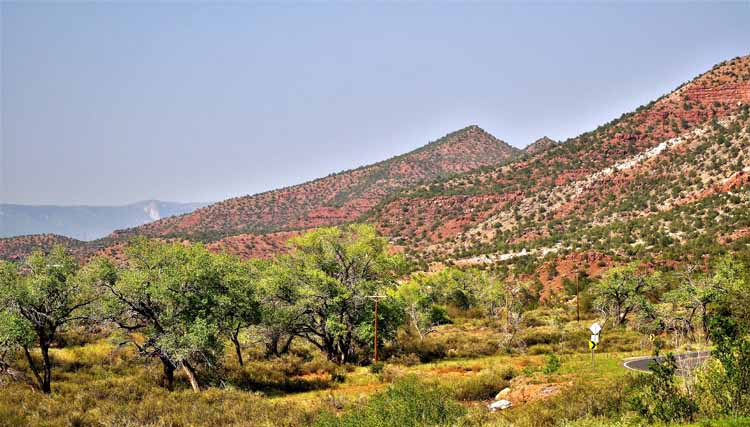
(99, 239), (234, 389)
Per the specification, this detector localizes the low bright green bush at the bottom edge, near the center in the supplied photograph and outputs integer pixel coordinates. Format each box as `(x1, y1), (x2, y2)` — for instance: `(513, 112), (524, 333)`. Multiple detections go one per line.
(315, 376), (466, 427)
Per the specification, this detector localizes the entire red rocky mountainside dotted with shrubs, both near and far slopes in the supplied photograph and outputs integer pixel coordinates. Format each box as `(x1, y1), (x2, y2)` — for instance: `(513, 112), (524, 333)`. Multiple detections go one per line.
(0, 56), (750, 270)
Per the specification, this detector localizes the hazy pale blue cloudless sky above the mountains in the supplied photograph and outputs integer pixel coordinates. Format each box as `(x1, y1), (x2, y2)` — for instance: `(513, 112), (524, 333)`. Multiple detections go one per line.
(0, 1), (750, 204)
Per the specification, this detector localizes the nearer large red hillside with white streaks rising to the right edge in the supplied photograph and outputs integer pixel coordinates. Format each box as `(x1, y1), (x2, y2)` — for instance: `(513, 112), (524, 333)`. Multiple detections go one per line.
(370, 56), (750, 264)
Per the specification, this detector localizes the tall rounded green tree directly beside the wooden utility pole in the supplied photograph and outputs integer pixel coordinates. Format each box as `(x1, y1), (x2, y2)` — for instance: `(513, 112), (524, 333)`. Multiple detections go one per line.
(266, 225), (404, 363)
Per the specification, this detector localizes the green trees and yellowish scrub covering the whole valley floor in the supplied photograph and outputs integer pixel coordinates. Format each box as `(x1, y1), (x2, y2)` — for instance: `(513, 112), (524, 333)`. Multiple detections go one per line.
(0, 225), (750, 427)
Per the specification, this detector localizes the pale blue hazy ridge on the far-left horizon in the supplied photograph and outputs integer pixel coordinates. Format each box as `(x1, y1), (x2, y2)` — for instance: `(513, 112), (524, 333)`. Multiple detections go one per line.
(0, 200), (206, 240)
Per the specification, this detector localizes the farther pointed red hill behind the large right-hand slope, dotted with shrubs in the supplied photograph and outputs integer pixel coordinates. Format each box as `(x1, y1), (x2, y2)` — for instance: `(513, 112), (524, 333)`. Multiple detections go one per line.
(112, 126), (519, 240)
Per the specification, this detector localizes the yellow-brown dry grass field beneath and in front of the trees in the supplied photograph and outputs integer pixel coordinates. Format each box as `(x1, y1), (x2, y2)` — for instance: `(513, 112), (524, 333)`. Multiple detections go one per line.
(0, 321), (728, 426)
